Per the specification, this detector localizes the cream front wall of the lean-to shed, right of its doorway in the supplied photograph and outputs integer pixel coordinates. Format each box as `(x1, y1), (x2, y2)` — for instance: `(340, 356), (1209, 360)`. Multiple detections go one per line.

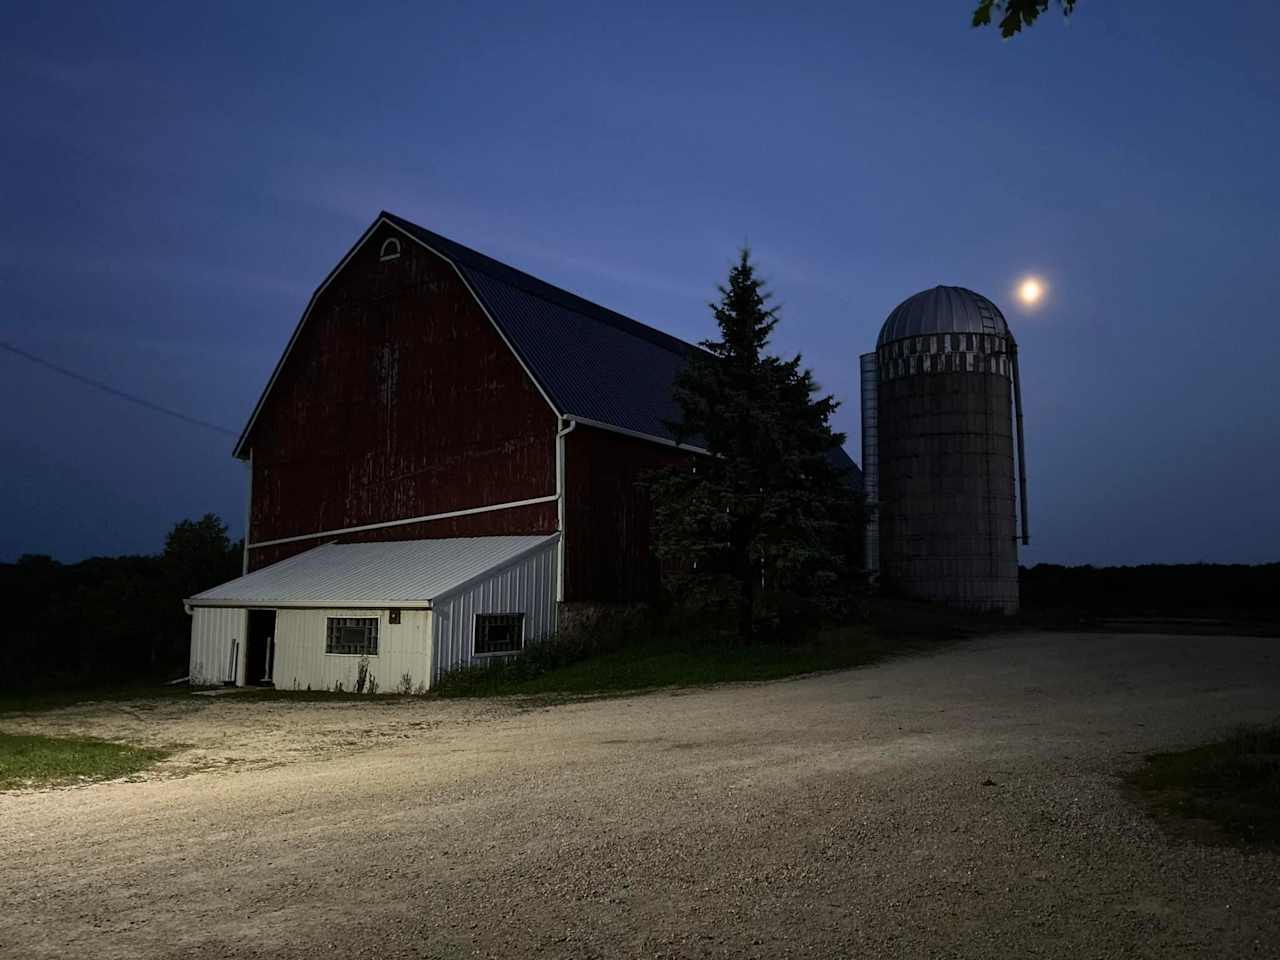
(271, 609), (431, 692)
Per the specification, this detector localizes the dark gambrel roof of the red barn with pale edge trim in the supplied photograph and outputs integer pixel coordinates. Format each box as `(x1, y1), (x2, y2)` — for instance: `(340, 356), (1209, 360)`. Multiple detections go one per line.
(236, 211), (860, 484)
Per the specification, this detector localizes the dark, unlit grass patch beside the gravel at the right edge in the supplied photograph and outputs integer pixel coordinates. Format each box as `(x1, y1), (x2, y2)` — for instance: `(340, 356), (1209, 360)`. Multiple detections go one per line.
(1130, 724), (1280, 847)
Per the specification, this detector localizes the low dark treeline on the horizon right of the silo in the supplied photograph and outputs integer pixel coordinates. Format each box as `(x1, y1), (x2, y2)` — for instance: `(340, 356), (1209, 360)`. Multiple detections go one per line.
(1020, 563), (1280, 621)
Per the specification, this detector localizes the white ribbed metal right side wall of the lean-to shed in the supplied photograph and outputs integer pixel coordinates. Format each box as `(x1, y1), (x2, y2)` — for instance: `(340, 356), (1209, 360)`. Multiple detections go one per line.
(431, 543), (559, 680)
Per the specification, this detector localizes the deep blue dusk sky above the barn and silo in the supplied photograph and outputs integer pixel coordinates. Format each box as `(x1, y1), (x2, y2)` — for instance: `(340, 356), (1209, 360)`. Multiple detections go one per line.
(0, 0), (1280, 563)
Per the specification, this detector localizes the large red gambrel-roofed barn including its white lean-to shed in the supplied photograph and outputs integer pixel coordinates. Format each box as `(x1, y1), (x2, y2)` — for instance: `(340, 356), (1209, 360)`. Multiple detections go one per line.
(188, 212), (856, 689)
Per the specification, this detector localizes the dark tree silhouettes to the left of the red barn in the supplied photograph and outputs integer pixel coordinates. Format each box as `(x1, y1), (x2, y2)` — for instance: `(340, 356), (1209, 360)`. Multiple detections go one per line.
(0, 513), (241, 691)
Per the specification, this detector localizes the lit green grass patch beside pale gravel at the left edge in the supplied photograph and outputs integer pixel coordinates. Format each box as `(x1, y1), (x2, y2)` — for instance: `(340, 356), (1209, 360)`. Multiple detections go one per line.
(0, 733), (166, 790)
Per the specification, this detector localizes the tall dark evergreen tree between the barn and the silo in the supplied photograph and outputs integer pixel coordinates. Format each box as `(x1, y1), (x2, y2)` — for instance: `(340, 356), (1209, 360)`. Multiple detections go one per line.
(652, 250), (856, 641)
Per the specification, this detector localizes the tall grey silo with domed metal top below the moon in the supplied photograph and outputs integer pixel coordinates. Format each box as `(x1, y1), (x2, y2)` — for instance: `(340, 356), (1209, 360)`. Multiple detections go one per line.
(861, 287), (1028, 613)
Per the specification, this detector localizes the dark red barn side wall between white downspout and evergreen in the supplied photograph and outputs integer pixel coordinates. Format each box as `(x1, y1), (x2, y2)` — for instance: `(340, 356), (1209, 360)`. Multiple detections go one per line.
(564, 425), (696, 602)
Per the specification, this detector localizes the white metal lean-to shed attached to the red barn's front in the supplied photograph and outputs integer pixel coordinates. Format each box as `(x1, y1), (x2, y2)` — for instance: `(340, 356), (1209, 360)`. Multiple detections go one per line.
(186, 534), (559, 692)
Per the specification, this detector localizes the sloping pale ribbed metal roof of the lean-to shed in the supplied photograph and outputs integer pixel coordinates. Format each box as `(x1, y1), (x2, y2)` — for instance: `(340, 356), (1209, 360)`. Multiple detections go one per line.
(187, 534), (559, 607)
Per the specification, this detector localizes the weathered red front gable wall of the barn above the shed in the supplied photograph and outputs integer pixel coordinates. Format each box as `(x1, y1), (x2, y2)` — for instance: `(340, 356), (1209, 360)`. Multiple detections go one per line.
(247, 225), (557, 570)
